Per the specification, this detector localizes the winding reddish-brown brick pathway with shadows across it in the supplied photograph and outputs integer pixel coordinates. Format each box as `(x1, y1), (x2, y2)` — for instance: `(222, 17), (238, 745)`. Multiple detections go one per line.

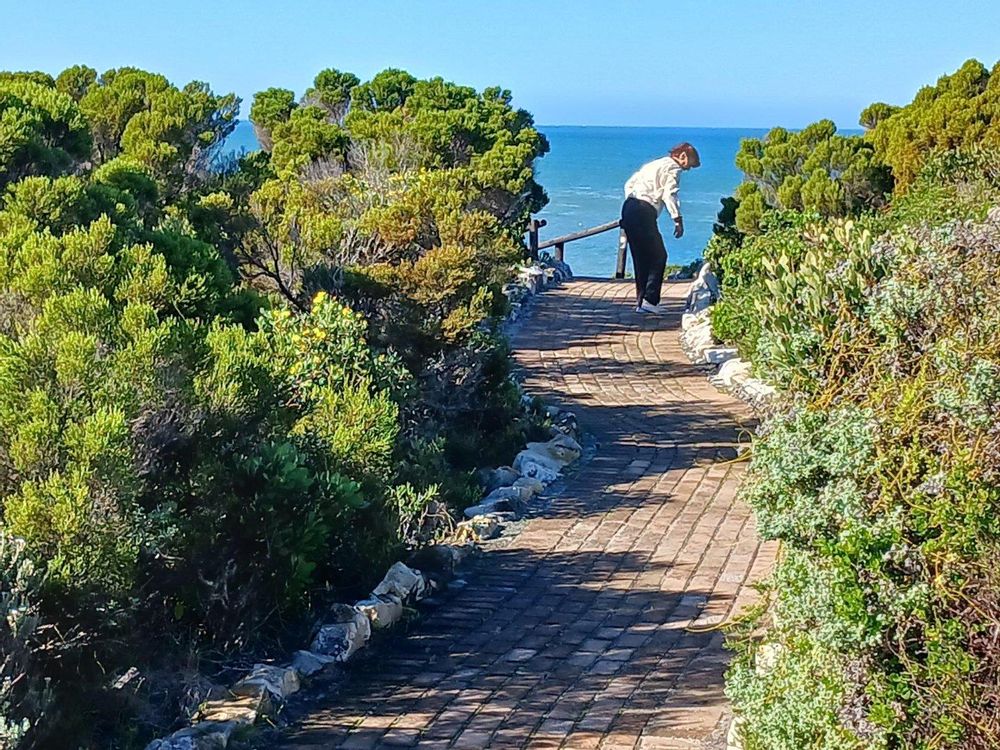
(281, 280), (774, 750)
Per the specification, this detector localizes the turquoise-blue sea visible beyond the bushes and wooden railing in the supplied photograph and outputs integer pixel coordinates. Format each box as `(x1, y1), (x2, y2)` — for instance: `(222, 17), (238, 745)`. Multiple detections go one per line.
(221, 122), (767, 277)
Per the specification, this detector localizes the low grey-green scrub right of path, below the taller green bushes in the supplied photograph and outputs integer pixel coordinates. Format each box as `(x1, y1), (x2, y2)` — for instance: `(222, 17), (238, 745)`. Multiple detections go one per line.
(730, 191), (1000, 748)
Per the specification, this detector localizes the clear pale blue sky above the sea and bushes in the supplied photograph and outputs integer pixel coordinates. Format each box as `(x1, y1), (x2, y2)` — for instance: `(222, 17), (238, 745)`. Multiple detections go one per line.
(0, 0), (1000, 127)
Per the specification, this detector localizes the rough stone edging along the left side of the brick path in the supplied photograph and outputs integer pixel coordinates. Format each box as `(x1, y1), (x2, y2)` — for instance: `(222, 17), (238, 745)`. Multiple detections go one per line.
(146, 256), (583, 750)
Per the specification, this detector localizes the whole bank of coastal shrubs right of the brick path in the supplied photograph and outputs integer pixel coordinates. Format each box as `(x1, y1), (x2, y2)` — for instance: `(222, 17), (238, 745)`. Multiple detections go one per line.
(706, 61), (1000, 750)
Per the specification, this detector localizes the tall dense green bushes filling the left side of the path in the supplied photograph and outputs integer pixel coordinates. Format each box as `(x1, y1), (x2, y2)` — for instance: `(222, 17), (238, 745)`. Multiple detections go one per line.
(0, 66), (548, 748)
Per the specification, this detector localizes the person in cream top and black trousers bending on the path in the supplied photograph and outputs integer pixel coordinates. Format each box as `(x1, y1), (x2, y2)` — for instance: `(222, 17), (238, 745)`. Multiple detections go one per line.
(621, 143), (701, 313)
